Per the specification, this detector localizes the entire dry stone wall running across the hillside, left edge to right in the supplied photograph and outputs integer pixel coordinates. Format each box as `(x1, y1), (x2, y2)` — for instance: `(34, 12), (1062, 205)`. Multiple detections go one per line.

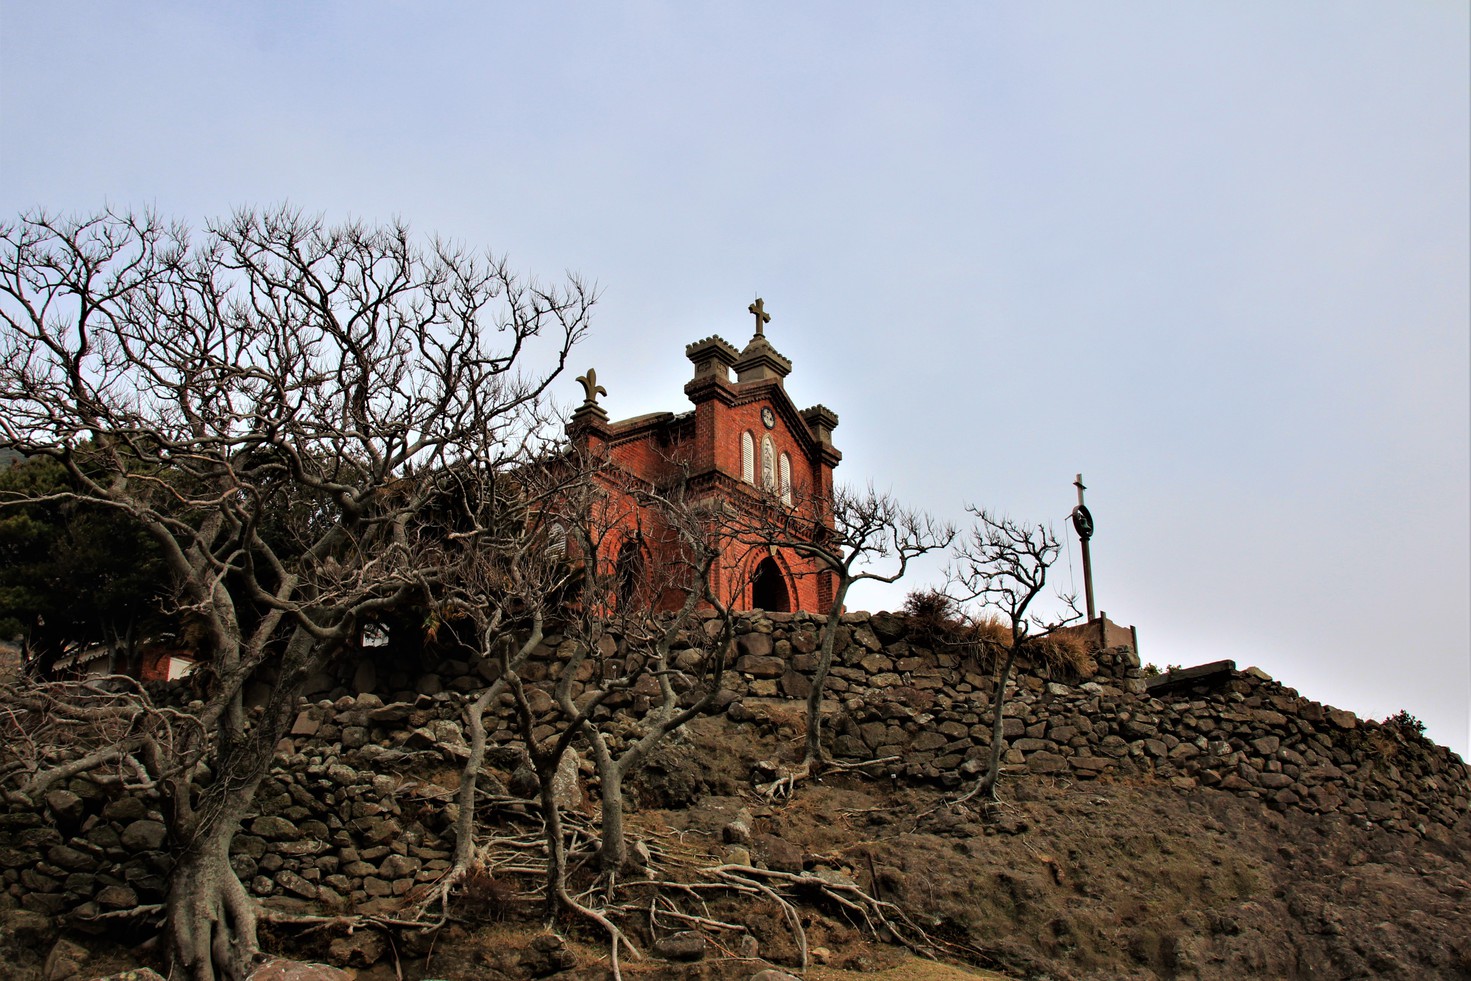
(0, 613), (1471, 924)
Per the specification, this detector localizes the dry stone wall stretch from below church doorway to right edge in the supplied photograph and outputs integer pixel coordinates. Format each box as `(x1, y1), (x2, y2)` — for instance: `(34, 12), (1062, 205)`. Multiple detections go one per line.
(728, 613), (1471, 835)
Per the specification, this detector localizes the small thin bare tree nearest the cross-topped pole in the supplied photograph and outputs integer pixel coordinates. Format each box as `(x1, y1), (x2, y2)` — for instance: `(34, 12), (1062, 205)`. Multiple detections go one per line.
(950, 506), (1081, 800)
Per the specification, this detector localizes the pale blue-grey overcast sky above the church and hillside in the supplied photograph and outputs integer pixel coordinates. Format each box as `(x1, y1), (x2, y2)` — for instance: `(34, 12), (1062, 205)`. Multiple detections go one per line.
(0, 0), (1471, 756)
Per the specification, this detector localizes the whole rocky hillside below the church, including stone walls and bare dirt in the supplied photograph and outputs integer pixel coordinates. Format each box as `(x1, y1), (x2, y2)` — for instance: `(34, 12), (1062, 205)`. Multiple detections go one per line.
(0, 615), (1471, 981)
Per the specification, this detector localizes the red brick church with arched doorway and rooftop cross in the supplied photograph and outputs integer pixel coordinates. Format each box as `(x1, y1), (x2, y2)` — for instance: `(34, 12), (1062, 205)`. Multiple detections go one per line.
(568, 300), (843, 612)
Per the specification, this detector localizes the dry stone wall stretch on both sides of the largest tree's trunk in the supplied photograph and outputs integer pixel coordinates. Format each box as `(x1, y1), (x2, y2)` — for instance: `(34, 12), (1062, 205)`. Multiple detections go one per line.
(0, 693), (463, 925)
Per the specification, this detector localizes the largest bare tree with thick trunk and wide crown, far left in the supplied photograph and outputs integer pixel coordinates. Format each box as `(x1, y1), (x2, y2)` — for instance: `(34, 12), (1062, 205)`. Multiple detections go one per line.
(0, 210), (593, 980)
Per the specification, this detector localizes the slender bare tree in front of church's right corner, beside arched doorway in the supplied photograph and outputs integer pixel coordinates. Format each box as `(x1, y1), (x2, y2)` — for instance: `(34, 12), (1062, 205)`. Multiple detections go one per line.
(728, 484), (956, 794)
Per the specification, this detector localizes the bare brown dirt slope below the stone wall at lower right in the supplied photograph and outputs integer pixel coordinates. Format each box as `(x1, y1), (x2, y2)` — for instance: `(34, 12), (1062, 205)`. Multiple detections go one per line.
(620, 719), (1471, 978)
